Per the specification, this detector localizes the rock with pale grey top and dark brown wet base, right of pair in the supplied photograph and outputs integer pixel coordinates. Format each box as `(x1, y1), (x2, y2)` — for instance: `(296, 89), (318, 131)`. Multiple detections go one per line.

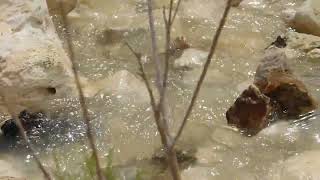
(254, 51), (316, 118)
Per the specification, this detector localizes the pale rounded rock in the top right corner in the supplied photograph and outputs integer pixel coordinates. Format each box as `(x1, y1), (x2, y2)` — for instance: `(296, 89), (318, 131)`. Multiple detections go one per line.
(290, 0), (320, 36)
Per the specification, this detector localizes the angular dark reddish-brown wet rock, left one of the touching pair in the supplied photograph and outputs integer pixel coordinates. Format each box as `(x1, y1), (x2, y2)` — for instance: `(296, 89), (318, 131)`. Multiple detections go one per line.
(226, 85), (271, 135)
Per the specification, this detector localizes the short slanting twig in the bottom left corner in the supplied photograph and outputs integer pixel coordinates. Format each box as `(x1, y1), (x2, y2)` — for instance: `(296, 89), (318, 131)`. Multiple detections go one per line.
(3, 93), (52, 180)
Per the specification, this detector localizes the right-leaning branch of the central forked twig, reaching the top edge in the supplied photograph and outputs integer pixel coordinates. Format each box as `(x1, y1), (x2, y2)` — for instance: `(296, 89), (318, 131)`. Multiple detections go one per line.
(171, 0), (232, 148)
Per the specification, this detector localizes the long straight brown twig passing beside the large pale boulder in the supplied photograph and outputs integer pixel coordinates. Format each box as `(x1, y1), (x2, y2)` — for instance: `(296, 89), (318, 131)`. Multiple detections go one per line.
(59, 2), (105, 180)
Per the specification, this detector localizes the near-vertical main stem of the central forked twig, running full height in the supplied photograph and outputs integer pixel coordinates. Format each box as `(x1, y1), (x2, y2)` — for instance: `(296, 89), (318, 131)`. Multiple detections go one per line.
(147, 0), (181, 180)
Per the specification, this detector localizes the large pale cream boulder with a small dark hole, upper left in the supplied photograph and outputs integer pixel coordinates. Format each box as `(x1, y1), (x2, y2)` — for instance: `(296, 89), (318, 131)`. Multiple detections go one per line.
(0, 1), (74, 113)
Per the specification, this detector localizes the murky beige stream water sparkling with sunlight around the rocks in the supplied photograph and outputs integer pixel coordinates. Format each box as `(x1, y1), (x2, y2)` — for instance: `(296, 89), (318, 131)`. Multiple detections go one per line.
(5, 0), (320, 179)
